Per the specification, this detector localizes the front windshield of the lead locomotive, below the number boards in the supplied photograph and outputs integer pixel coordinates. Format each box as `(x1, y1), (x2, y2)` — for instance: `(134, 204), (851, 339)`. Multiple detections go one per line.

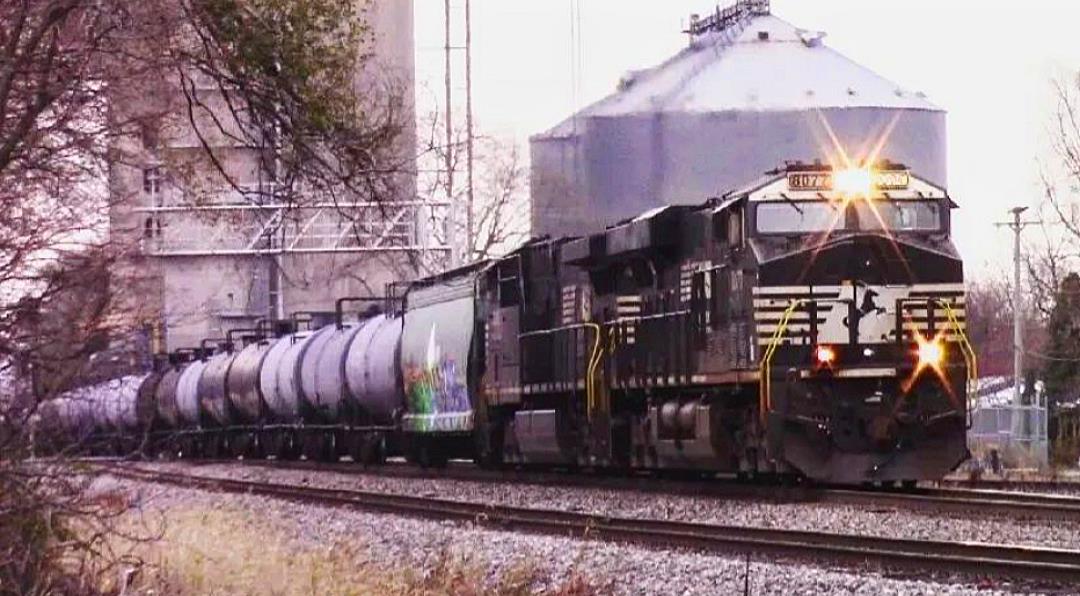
(756, 201), (942, 234)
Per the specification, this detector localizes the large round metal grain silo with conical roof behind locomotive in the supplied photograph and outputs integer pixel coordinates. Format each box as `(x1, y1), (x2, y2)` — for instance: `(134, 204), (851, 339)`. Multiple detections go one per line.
(531, 0), (946, 235)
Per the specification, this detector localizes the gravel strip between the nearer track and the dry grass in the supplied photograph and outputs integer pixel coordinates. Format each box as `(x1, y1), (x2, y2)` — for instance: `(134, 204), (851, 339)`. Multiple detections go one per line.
(97, 477), (1045, 595)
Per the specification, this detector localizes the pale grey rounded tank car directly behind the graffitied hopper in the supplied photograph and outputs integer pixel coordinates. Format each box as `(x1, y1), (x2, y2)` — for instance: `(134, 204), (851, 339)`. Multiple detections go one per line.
(345, 315), (405, 423)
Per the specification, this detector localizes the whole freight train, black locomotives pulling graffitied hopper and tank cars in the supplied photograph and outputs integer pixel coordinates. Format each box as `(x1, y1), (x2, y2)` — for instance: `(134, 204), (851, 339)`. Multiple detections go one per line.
(42, 163), (975, 484)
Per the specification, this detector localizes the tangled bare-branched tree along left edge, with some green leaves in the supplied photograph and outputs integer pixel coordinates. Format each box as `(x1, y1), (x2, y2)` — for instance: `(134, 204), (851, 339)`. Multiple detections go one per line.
(0, 0), (411, 594)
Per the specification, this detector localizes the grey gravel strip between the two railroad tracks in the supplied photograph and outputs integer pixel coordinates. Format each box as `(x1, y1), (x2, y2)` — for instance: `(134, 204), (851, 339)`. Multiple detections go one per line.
(137, 463), (1080, 550)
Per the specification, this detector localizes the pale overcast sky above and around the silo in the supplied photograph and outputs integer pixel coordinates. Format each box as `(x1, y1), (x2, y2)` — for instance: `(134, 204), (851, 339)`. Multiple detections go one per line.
(416, 0), (1080, 273)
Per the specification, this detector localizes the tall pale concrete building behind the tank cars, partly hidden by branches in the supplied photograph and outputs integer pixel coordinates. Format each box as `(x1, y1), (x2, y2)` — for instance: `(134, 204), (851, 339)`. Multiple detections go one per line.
(110, 0), (429, 351)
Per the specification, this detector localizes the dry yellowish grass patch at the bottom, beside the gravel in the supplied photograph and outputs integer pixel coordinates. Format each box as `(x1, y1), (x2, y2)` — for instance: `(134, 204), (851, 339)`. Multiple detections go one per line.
(106, 509), (606, 596)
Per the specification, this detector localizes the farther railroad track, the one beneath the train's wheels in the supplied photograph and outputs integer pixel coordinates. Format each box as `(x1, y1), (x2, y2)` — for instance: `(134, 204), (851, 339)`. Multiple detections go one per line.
(86, 453), (1080, 523)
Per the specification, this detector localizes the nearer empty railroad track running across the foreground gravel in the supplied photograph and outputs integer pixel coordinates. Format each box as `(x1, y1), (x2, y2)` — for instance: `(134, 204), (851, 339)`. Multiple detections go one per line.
(98, 463), (1080, 583)
